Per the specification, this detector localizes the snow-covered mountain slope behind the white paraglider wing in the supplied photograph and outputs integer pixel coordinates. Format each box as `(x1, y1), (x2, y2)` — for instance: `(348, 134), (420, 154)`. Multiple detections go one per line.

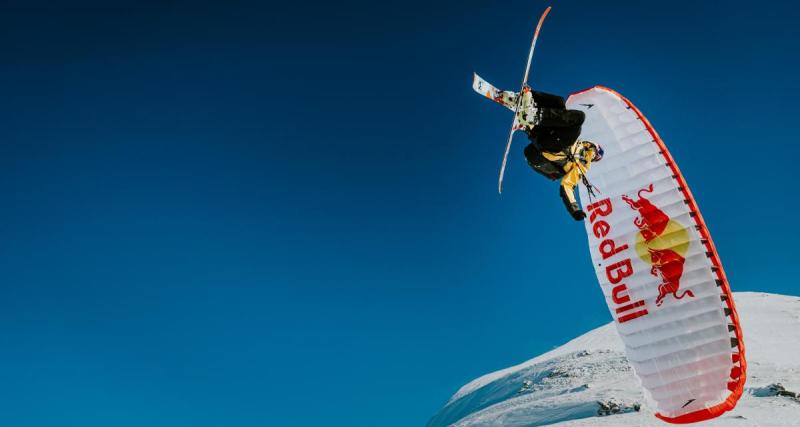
(428, 292), (800, 427)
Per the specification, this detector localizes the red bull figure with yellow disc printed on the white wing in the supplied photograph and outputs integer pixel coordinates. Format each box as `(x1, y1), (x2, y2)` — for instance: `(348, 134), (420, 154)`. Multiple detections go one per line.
(622, 184), (694, 306)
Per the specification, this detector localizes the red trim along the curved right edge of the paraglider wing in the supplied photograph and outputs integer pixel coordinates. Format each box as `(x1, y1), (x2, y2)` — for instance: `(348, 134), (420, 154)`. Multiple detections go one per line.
(570, 86), (747, 424)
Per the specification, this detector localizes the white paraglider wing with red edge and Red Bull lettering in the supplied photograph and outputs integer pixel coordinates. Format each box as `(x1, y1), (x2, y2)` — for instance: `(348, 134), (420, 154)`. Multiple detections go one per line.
(567, 86), (746, 423)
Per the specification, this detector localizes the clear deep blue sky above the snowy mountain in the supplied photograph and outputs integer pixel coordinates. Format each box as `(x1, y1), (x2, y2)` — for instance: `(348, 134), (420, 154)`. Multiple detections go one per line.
(0, 1), (800, 427)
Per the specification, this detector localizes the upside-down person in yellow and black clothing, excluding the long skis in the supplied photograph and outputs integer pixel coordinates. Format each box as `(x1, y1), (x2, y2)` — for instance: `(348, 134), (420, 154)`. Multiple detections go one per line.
(494, 86), (603, 221)
